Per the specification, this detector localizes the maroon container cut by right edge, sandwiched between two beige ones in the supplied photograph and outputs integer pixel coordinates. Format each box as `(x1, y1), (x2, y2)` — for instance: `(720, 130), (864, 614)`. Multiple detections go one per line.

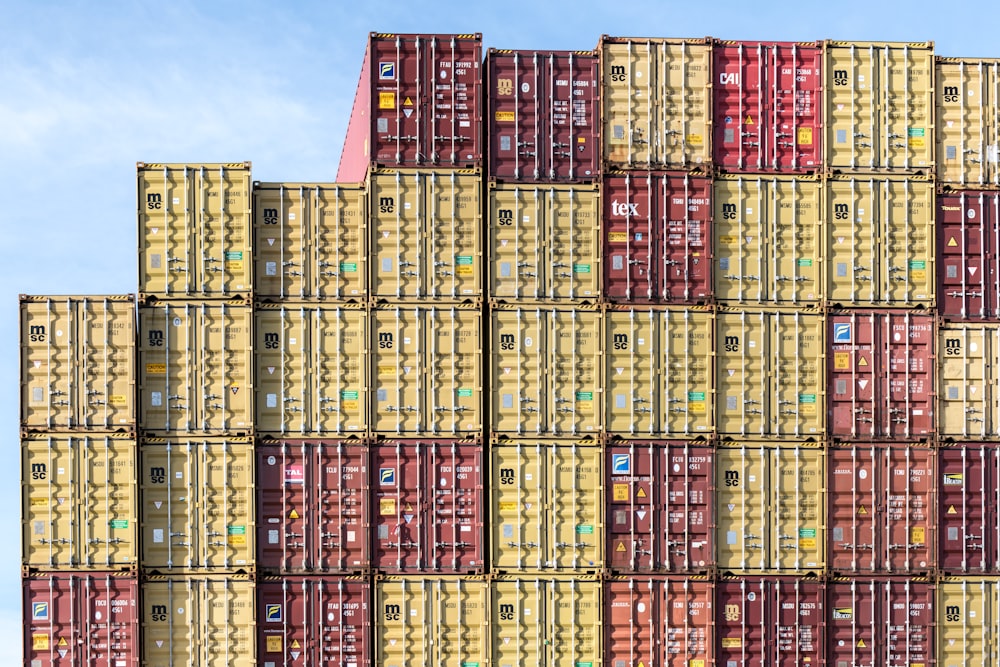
(937, 190), (1000, 320)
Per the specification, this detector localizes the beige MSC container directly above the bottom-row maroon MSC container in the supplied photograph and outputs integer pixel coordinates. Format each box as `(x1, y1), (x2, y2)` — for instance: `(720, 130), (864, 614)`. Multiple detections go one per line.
(715, 441), (827, 576)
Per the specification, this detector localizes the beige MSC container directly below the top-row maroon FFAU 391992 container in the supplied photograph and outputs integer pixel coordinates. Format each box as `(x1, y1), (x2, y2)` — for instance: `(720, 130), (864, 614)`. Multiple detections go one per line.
(369, 169), (483, 300)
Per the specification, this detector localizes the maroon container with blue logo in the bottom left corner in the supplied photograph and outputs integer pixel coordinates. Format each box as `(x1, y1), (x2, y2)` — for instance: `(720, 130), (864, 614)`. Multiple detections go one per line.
(22, 572), (139, 667)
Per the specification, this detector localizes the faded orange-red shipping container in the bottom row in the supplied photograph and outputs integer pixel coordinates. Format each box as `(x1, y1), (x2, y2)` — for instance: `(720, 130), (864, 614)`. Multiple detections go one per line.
(604, 577), (716, 667)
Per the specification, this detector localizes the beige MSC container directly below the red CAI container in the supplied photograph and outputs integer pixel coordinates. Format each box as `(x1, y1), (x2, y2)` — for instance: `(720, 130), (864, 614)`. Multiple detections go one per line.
(714, 174), (825, 306)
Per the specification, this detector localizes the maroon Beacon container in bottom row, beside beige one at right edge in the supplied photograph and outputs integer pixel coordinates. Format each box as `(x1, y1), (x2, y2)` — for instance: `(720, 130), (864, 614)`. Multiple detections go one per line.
(826, 577), (935, 667)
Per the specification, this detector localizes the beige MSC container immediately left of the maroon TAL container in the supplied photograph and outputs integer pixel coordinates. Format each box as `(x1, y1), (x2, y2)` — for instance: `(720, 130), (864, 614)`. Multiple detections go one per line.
(139, 438), (256, 574)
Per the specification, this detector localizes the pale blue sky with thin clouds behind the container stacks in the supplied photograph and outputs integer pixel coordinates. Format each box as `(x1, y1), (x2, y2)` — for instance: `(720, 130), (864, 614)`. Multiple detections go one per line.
(0, 0), (1000, 664)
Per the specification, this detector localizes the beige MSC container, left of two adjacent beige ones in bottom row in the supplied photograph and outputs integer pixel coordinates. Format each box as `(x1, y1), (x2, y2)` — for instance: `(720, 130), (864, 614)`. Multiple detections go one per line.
(372, 576), (490, 667)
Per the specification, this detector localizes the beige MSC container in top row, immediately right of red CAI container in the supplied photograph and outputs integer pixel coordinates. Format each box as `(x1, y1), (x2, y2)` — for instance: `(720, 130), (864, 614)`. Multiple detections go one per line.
(824, 41), (935, 174)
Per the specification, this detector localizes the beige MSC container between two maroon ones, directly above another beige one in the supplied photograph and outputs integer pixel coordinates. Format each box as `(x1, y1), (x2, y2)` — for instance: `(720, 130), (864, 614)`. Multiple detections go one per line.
(489, 438), (605, 573)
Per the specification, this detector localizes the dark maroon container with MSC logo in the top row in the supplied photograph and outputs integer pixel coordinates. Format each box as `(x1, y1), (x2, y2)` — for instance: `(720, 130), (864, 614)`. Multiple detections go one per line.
(485, 49), (601, 183)
